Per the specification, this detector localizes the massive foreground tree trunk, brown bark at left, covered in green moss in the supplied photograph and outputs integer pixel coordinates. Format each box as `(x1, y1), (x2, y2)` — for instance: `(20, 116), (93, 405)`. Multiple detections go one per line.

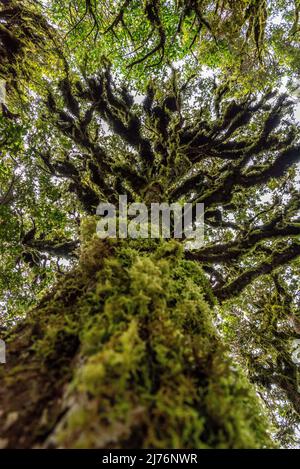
(0, 239), (271, 448)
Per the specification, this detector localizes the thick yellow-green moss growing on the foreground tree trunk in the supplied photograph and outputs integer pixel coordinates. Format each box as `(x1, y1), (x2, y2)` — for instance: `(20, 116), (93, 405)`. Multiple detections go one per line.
(34, 239), (271, 448)
